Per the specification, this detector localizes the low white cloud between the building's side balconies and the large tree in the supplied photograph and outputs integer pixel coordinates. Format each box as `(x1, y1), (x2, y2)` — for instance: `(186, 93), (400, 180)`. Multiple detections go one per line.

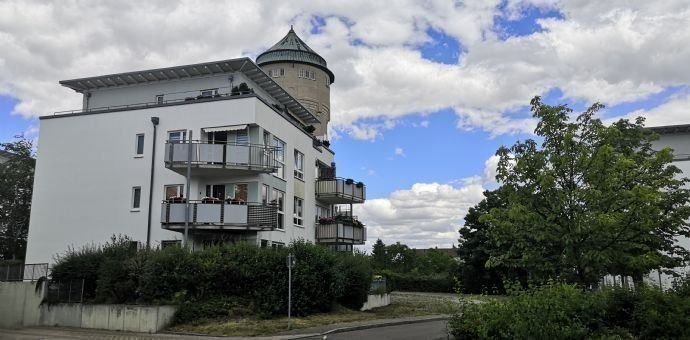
(355, 156), (496, 250)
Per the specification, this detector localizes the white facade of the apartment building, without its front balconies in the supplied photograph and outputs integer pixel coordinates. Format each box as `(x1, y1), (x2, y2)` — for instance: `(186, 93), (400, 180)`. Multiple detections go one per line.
(26, 58), (363, 263)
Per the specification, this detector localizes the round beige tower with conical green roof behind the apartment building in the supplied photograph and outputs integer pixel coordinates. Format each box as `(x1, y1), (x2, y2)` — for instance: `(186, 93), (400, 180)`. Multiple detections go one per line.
(256, 27), (335, 140)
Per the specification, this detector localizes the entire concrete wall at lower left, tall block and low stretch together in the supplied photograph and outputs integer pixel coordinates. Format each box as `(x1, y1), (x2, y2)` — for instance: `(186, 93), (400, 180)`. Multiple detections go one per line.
(0, 282), (176, 333)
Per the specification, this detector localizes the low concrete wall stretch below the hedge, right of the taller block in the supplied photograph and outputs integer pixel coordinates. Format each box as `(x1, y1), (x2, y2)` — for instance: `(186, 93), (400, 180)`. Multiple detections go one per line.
(39, 303), (176, 333)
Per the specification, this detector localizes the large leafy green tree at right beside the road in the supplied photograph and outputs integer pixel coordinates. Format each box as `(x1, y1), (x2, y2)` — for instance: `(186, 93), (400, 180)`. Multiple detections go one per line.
(480, 97), (690, 287)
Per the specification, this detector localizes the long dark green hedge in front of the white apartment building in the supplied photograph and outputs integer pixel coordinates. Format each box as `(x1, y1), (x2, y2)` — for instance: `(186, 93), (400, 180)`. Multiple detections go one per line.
(52, 238), (372, 321)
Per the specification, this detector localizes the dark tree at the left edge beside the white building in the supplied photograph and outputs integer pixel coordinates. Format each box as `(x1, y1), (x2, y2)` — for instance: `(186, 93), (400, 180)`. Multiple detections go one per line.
(0, 136), (35, 260)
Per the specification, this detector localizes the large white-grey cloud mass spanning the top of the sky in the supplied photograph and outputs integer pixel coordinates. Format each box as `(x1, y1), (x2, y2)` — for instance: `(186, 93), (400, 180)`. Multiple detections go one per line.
(0, 0), (690, 140)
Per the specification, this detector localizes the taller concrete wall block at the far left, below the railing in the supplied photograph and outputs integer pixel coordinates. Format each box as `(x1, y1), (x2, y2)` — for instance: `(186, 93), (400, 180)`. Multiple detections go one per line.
(0, 282), (45, 328)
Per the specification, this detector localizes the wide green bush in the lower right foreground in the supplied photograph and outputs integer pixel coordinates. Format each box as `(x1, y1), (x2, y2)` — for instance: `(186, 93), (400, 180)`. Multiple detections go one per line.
(449, 284), (690, 339)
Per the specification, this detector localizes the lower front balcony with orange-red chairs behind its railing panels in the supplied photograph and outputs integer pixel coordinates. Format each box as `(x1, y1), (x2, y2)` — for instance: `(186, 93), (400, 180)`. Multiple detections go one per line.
(161, 200), (278, 231)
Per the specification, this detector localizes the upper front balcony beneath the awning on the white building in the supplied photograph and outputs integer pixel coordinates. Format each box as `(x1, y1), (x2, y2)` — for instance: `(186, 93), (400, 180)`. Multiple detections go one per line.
(165, 141), (278, 176)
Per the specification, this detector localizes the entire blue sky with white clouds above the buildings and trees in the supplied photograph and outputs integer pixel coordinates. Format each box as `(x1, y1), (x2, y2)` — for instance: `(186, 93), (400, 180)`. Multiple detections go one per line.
(0, 0), (690, 248)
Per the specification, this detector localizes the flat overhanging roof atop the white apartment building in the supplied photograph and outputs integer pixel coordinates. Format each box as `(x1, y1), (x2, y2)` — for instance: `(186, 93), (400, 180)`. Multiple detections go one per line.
(60, 57), (319, 124)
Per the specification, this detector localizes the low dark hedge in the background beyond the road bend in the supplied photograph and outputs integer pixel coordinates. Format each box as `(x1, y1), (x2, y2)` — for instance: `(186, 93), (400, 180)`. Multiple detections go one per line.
(381, 271), (455, 293)
